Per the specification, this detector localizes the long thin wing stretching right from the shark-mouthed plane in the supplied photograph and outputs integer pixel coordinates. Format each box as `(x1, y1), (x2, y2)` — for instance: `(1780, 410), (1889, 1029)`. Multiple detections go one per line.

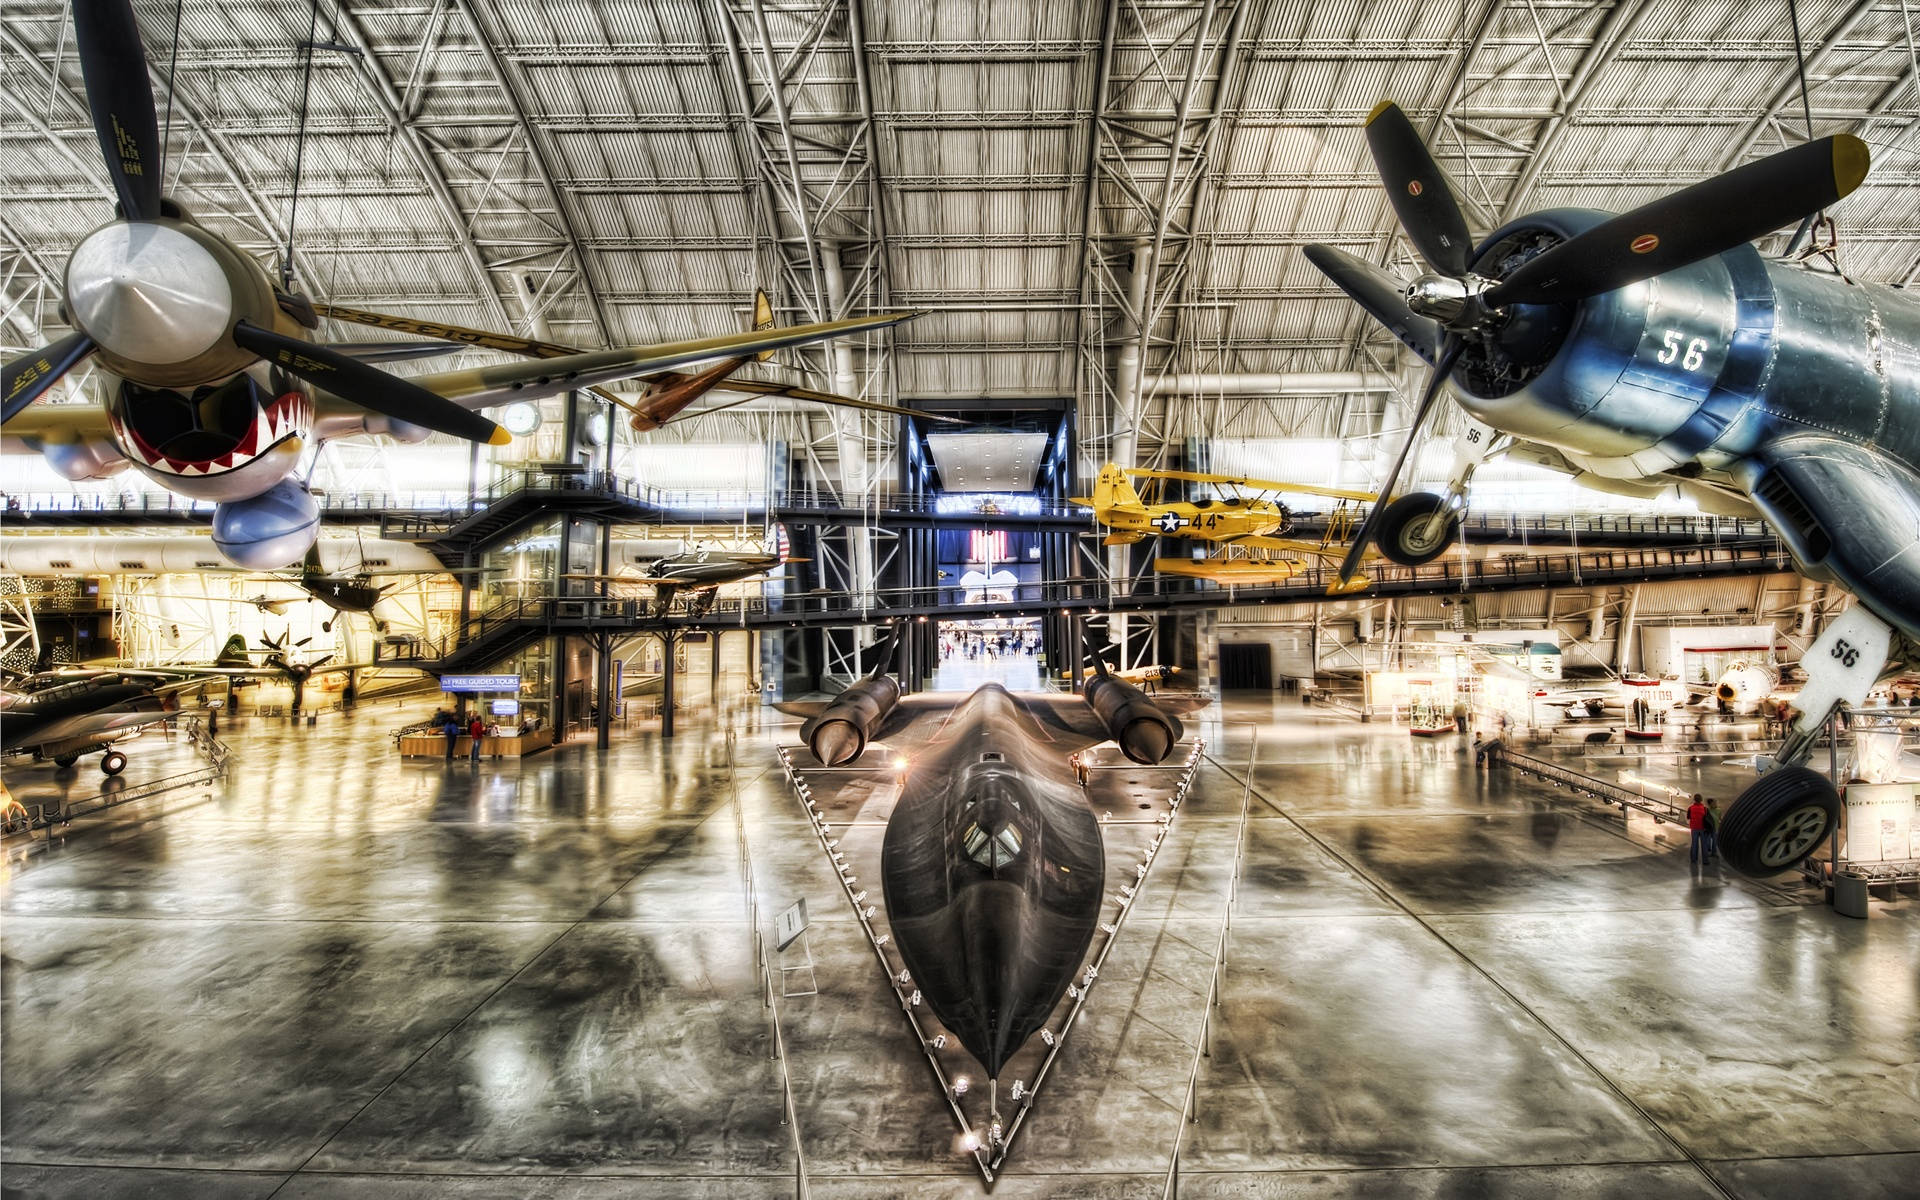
(372, 313), (918, 409)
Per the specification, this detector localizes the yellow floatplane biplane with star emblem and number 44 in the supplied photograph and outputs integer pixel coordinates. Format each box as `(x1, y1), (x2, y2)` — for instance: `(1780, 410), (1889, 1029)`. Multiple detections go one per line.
(1073, 463), (1375, 593)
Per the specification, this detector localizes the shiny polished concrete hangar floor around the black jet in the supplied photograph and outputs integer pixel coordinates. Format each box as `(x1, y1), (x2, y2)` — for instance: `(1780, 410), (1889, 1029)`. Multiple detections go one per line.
(0, 699), (1920, 1200)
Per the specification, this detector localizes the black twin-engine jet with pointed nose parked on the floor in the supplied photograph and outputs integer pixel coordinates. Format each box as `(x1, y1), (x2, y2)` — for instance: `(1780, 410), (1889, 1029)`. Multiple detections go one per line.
(778, 641), (1208, 1079)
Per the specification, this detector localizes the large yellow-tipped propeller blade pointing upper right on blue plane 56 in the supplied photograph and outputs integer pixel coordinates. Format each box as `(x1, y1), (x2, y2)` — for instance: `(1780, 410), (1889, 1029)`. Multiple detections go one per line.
(1486, 132), (1870, 305)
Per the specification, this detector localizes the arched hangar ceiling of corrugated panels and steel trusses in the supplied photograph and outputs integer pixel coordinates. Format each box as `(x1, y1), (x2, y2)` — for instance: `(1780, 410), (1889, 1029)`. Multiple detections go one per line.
(0, 0), (1920, 468)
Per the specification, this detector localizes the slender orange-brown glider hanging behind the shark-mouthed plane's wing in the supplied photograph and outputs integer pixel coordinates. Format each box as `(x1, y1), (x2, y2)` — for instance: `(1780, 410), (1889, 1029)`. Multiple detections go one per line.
(313, 292), (966, 434)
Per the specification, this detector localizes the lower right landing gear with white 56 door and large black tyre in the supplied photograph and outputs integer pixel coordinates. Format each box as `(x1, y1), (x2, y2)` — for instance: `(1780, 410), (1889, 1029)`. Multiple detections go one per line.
(1716, 605), (1893, 876)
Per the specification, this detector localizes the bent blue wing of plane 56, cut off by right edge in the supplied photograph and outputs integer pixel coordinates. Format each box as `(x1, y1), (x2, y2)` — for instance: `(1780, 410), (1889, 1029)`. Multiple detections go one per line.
(1747, 434), (1920, 637)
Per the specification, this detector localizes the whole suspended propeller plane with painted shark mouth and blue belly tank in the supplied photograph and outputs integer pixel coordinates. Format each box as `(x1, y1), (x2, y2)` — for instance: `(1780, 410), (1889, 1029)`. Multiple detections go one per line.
(0, 0), (910, 568)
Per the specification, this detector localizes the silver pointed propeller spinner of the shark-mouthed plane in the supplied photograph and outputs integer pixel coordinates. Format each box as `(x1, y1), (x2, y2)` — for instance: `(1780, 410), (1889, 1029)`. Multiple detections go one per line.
(67, 221), (234, 367)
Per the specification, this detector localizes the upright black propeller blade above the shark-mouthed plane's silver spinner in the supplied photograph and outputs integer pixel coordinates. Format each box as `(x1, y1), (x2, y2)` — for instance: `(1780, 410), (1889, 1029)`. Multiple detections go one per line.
(73, 0), (159, 221)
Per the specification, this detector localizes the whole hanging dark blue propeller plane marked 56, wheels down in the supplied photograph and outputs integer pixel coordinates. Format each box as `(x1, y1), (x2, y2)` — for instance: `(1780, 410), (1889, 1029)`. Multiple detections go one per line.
(1306, 104), (1920, 874)
